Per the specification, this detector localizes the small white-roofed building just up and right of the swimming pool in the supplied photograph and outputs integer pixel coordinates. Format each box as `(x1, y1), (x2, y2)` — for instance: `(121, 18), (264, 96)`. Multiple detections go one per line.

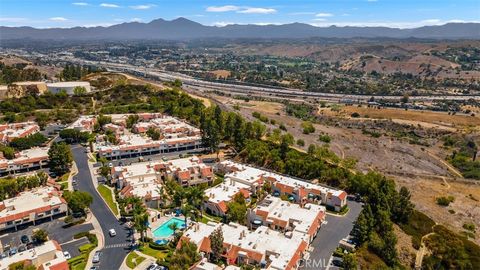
(204, 179), (251, 216)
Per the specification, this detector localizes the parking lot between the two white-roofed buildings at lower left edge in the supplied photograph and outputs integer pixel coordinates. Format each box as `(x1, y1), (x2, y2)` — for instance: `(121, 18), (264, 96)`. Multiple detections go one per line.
(0, 219), (93, 256)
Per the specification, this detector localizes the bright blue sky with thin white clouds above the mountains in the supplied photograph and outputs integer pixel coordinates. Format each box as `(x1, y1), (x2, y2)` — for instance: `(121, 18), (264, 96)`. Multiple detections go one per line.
(0, 0), (480, 28)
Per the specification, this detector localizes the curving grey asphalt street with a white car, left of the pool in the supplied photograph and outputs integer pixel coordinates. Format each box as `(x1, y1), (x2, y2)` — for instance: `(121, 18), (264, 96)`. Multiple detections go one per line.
(71, 145), (130, 270)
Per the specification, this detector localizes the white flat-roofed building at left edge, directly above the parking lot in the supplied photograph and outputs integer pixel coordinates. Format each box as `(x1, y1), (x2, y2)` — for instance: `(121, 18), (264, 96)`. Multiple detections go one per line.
(0, 187), (68, 231)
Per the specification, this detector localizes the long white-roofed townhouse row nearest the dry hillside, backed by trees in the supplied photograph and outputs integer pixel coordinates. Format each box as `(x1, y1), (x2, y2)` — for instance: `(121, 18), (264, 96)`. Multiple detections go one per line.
(218, 160), (347, 211)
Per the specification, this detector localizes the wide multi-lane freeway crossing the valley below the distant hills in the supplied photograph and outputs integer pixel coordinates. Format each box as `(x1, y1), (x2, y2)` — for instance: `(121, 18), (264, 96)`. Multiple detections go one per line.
(69, 58), (480, 102)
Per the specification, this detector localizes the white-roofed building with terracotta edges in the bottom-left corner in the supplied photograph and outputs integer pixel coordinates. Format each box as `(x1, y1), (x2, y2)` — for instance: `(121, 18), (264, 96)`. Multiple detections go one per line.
(0, 240), (70, 270)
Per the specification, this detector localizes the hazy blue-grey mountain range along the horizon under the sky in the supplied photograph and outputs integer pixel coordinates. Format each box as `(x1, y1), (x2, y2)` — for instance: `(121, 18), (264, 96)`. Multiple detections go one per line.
(0, 18), (480, 40)
